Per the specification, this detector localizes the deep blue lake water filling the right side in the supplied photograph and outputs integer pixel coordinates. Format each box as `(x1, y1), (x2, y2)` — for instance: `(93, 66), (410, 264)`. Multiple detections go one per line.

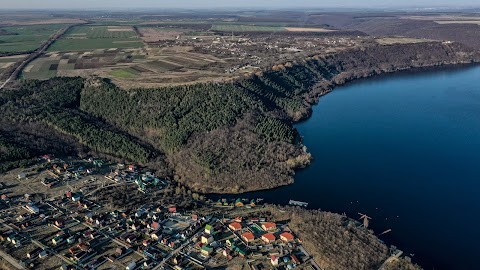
(244, 67), (480, 270)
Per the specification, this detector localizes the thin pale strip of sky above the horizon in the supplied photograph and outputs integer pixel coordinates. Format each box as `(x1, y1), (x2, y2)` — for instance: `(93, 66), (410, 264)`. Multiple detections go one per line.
(0, 0), (480, 9)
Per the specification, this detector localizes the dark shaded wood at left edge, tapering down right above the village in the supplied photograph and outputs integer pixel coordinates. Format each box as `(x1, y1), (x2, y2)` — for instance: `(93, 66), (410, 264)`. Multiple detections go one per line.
(0, 78), (156, 163)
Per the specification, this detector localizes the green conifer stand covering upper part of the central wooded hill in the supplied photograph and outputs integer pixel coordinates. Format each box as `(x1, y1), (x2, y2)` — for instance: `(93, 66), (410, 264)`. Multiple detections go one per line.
(80, 78), (272, 152)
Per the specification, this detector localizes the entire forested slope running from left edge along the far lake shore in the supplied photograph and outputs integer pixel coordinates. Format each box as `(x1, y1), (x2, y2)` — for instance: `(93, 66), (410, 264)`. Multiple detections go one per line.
(0, 42), (480, 193)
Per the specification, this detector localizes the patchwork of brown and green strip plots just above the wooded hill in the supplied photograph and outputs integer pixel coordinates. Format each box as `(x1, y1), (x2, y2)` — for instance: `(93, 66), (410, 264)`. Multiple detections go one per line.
(23, 47), (230, 86)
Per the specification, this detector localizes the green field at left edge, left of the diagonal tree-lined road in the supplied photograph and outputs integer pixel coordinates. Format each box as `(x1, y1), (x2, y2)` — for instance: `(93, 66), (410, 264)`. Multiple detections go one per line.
(0, 24), (66, 53)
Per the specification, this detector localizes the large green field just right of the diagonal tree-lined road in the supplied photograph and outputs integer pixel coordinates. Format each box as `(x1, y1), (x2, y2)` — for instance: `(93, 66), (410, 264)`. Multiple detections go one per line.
(48, 26), (143, 52)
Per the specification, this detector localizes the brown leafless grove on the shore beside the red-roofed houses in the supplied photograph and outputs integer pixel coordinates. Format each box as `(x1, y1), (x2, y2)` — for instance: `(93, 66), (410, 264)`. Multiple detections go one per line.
(269, 206), (388, 270)
